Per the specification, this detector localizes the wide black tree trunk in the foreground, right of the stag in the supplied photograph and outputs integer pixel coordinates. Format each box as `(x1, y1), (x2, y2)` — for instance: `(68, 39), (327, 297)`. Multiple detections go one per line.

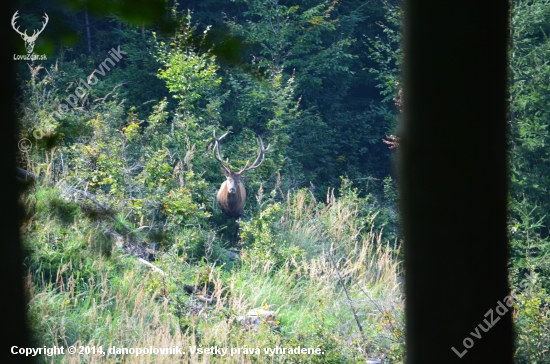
(399, 0), (513, 364)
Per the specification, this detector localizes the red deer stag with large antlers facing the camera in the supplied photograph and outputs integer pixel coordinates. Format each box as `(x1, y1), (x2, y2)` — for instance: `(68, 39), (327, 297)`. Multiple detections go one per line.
(213, 131), (270, 238)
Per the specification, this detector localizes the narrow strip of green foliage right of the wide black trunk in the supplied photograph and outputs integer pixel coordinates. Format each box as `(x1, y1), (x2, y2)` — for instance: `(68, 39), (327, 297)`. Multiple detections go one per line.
(508, 0), (550, 363)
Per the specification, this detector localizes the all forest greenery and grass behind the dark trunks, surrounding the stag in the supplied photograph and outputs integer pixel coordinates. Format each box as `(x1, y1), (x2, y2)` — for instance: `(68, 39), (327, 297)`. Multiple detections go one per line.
(11, 0), (550, 363)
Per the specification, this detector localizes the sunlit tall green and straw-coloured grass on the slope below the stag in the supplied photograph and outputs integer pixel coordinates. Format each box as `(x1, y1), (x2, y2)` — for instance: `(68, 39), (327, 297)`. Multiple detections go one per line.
(22, 187), (404, 363)
